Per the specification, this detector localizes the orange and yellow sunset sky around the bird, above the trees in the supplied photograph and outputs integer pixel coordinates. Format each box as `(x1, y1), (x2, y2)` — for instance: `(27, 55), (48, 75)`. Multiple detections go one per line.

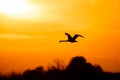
(0, 0), (120, 72)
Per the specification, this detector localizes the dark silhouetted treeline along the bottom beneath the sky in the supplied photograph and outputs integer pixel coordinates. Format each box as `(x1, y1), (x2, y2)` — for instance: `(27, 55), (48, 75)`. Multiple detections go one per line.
(0, 56), (120, 80)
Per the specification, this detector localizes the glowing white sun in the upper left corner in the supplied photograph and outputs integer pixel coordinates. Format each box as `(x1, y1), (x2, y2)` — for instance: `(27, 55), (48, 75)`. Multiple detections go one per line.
(0, 0), (31, 15)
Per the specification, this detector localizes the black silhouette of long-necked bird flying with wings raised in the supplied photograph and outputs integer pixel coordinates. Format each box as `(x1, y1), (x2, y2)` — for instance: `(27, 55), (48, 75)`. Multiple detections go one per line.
(59, 33), (84, 43)
